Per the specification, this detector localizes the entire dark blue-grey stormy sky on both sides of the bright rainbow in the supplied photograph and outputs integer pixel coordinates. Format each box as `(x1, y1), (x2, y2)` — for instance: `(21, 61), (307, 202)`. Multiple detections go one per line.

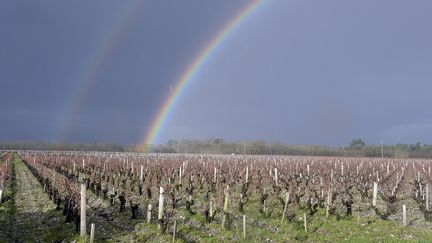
(0, 0), (432, 146)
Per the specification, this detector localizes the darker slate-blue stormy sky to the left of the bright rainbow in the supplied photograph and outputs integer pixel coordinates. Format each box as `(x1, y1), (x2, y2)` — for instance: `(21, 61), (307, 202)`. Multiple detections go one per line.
(0, 0), (250, 143)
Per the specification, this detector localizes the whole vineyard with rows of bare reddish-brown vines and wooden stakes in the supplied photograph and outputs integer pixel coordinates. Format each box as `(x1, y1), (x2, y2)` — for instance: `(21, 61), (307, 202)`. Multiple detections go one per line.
(0, 151), (432, 242)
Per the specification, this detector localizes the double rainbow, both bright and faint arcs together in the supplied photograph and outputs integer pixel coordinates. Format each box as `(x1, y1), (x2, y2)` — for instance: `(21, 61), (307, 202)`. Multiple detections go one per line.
(57, 0), (261, 146)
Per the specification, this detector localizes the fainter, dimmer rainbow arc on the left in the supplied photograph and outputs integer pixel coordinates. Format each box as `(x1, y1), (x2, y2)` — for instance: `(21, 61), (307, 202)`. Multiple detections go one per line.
(56, 0), (144, 141)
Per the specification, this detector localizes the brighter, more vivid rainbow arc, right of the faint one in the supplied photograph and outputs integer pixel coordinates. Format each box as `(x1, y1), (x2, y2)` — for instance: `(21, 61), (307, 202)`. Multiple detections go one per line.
(141, 0), (261, 146)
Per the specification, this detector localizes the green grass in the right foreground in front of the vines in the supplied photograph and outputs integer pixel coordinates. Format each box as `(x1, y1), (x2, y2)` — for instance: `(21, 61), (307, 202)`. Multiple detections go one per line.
(103, 197), (432, 242)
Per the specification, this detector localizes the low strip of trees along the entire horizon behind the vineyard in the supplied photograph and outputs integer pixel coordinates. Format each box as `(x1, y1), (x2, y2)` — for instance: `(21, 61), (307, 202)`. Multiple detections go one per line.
(0, 138), (432, 158)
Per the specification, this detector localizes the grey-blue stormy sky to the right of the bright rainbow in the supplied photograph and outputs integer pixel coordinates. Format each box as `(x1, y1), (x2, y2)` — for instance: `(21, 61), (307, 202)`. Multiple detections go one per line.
(160, 1), (432, 145)
